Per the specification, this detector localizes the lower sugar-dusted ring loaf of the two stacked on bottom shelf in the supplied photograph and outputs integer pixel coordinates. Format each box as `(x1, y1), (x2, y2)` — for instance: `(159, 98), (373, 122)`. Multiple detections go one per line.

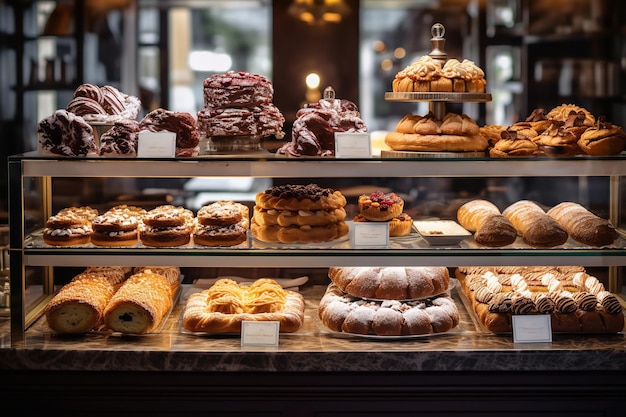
(318, 284), (459, 336)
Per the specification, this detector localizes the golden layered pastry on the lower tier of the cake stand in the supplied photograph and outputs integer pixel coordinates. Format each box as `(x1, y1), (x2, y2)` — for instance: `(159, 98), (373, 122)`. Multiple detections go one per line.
(385, 113), (487, 152)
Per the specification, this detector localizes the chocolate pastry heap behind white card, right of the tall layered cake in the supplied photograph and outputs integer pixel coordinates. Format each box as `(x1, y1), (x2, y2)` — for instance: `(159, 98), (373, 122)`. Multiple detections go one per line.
(276, 87), (367, 156)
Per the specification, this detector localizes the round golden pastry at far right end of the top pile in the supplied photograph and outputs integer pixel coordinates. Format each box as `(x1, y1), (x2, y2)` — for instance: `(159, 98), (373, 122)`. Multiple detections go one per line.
(578, 116), (626, 156)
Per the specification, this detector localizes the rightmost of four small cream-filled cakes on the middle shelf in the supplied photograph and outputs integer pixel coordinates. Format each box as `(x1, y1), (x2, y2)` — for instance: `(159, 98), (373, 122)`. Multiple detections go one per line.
(193, 200), (250, 246)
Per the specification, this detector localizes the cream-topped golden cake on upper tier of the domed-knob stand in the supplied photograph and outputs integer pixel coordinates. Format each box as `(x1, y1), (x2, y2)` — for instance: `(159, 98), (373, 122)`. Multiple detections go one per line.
(392, 55), (487, 93)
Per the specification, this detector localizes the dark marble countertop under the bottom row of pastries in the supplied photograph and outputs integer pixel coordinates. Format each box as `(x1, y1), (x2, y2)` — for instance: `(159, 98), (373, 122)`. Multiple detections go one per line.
(0, 286), (626, 372)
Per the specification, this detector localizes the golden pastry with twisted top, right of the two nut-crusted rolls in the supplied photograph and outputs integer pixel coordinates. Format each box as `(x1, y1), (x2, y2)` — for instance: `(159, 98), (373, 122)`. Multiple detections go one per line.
(183, 278), (304, 334)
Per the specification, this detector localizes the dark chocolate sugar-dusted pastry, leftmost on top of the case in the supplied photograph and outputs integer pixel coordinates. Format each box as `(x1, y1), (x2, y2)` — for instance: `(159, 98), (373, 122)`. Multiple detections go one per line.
(37, 110), (98, 156)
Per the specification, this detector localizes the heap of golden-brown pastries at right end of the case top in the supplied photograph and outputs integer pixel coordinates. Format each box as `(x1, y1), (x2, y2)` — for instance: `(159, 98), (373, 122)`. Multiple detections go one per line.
(480, 104), (626, 158)
